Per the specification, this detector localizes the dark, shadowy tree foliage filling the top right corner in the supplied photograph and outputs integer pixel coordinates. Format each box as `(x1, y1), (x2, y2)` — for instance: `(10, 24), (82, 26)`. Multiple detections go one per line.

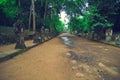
(89, 0), (120, 30)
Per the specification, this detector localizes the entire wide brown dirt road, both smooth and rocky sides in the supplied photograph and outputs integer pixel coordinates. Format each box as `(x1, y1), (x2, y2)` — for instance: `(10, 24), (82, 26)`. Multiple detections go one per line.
(0, 34), (120, 80)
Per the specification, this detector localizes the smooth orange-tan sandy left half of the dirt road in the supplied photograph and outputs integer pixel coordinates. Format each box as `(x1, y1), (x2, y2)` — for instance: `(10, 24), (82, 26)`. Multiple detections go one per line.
(0, 34), (71, 80)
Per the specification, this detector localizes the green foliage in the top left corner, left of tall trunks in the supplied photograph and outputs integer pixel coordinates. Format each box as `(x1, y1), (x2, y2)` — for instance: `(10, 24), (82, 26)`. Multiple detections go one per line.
(0, 0), (20, 26)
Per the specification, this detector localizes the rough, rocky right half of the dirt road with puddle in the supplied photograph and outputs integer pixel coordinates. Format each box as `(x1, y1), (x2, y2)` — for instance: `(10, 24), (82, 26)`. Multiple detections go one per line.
(62, 35), (120, 80)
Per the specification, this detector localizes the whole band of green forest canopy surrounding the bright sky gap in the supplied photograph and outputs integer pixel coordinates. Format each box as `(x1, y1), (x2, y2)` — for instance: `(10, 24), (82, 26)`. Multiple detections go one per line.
(0, 0), (120, 32)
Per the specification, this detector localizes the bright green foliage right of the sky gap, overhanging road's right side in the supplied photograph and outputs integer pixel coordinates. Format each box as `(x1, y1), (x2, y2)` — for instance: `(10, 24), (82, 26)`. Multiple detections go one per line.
(69, 1), (113, 32)
